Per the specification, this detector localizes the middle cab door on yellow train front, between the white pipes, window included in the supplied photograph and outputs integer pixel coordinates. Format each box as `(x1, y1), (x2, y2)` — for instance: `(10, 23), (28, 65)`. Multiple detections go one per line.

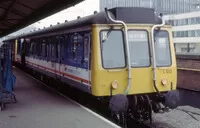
(128, 29), (153, 94)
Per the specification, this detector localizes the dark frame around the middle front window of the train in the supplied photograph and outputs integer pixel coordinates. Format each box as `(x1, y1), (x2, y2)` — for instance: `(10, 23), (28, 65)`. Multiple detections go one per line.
(127, 29), (152, 68)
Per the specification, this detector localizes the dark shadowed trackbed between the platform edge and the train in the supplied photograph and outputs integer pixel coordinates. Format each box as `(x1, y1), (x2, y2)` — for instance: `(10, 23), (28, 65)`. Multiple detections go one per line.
(15, 65), (153, 128)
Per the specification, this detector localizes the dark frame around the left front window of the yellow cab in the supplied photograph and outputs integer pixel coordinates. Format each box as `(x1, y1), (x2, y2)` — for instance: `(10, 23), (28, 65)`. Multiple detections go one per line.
(99, 28), (127, 70)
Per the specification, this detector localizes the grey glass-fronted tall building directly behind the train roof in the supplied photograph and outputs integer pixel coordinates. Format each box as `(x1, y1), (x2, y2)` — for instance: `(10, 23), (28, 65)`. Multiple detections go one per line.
(100, 0), (200, 14)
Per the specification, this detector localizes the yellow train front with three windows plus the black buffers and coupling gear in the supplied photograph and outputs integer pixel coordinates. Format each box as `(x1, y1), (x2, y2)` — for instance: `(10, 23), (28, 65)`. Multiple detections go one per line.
(91, 24), (178, 122)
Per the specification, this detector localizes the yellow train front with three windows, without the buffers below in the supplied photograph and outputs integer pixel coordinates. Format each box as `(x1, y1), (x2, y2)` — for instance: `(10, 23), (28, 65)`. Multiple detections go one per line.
(92, 25), (177, 96)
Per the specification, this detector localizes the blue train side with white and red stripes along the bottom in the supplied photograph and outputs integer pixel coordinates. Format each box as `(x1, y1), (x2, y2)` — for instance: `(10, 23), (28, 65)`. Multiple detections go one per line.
(16, 28), (91, 93)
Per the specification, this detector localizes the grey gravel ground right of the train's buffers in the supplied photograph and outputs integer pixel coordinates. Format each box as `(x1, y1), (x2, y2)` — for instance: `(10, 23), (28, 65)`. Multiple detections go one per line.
(153, 106), (200, 128)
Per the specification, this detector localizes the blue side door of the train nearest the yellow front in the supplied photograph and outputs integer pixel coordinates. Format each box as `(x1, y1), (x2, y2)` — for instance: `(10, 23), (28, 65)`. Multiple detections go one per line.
(71, 31), (91, 88)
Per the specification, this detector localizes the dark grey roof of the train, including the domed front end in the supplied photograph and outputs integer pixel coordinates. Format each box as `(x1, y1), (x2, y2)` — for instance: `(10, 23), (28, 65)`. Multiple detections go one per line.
(3, 7), (165, 41)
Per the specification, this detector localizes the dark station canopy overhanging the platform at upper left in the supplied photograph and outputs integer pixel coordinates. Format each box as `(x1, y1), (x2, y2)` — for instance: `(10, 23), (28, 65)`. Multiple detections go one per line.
(0, 0), (83, 37)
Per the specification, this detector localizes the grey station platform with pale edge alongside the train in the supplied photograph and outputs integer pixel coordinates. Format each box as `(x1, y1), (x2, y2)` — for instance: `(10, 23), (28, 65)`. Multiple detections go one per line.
(0, 68), (119, 128)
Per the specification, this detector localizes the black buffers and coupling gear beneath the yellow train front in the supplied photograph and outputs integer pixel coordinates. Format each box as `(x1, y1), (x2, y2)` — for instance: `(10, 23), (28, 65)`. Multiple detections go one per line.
(109, 90), (180, 125)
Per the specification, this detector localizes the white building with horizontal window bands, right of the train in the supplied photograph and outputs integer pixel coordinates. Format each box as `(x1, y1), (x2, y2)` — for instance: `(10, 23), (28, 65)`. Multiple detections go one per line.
(165, 11), (200, 53)
